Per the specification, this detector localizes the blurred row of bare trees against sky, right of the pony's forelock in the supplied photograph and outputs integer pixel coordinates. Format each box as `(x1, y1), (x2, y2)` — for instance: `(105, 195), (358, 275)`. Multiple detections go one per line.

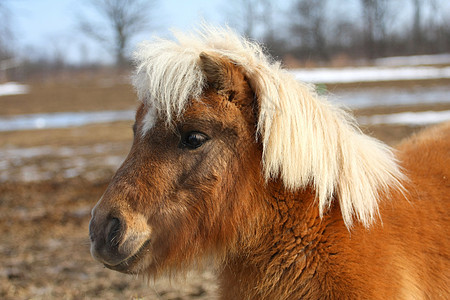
(224, 0), (450, 61)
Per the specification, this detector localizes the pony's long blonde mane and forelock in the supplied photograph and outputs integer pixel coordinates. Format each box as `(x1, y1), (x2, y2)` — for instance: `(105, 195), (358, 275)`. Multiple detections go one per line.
(133, 26), (403, 227)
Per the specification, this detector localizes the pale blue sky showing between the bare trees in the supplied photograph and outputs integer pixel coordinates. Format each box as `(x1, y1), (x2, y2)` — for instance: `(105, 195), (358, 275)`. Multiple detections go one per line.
(6, 0), (450, 63)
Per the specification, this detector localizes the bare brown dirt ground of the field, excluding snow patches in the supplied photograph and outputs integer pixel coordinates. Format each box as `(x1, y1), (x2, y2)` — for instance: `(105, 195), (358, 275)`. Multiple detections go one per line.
(0, 83), (450, 299)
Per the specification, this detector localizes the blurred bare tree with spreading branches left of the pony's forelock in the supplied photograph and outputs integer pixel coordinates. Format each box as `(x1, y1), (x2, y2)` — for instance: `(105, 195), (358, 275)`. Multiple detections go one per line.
(79, 0), (155, 67)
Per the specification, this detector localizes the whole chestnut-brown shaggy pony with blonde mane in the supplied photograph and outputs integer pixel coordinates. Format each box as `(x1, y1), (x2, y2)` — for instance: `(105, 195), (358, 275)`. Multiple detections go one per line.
(89, 26), (450, 299)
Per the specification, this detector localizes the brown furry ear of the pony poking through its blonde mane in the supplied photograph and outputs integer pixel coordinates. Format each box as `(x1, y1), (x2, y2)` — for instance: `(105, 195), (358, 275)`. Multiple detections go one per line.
(200, 52), (244, 101)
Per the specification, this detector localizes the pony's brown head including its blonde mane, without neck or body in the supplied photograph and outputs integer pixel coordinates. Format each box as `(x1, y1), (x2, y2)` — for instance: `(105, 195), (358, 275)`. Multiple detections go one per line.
(90, 27), (402, 273)
